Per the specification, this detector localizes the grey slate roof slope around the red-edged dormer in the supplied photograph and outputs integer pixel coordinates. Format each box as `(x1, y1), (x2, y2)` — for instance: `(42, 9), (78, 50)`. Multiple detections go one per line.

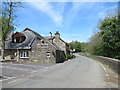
(5, 28), (43, 49)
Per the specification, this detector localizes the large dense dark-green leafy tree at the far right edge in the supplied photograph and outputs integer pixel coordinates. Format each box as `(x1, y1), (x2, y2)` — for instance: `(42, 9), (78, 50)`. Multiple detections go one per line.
(98, 15), (120, 58)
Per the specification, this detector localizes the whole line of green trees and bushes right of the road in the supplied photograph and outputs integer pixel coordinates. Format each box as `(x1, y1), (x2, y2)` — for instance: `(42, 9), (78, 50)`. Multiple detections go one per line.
(69, 14), (120, 59)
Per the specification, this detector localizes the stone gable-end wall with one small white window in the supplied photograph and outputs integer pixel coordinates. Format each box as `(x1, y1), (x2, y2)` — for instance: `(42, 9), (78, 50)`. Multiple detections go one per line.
(30, 40), (56, 63)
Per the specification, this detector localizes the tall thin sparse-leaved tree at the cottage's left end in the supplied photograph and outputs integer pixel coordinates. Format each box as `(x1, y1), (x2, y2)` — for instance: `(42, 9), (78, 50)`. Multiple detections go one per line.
(1, 1), (21, 59)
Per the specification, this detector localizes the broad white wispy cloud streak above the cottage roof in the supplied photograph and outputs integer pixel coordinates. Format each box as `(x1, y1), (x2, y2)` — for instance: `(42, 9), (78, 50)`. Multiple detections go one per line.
(29, 2), (63, 26)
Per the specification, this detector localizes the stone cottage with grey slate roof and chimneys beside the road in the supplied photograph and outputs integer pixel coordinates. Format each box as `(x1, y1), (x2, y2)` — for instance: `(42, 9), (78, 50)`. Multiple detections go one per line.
(5, 28), (68, 63)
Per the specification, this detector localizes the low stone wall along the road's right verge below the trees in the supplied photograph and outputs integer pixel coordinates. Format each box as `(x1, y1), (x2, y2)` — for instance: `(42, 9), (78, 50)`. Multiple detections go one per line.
(88, 55), (120, 74)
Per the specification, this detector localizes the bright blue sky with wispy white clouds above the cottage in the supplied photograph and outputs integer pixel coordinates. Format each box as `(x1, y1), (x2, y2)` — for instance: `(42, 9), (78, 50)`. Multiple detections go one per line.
(15, 2), (117, 42)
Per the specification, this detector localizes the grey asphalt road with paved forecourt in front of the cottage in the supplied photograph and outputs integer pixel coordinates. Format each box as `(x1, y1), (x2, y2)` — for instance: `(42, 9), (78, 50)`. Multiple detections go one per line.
(2, 54), (118, 88)
